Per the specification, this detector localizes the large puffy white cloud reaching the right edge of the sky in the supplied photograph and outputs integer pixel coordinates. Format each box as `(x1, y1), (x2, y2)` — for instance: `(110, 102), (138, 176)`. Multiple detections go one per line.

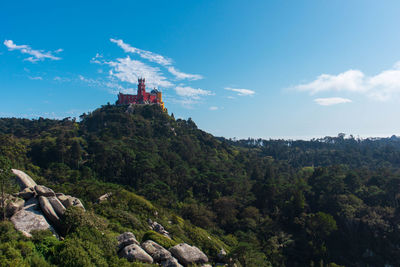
(294, 62), (400, 101)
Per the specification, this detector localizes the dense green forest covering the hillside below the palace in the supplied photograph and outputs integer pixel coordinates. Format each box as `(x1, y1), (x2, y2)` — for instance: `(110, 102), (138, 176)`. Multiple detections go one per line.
(0, 105), (400, 266)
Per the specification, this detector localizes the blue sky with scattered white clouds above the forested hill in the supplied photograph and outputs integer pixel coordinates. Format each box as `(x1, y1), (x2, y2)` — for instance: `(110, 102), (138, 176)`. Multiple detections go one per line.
(0, 0), (400, 139)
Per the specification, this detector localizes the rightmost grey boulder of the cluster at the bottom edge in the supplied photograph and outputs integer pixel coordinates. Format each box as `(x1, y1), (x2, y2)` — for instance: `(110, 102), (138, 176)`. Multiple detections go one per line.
(169, 243), (208, 266)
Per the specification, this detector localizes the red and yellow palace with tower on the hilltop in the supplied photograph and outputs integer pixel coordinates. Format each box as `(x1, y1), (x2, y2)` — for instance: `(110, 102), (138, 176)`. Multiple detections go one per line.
(116, 78), (165, 110)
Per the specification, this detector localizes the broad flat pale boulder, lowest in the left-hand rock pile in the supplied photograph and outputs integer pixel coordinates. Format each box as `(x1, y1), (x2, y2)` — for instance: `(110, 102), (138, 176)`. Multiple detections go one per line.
(11, 198), (56, 237)
